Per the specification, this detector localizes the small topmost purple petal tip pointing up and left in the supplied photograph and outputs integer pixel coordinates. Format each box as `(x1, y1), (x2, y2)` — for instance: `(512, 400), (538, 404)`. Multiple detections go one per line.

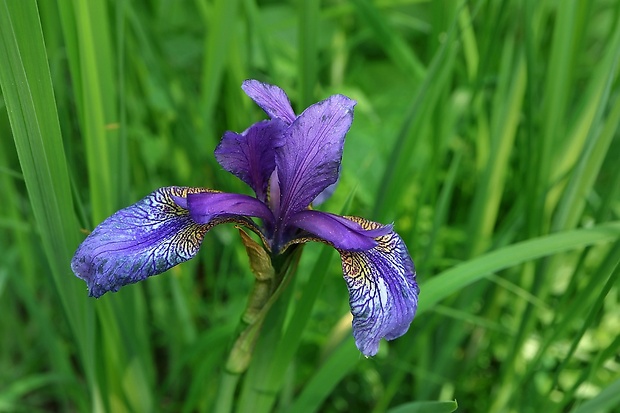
(241, 79), (296, 124)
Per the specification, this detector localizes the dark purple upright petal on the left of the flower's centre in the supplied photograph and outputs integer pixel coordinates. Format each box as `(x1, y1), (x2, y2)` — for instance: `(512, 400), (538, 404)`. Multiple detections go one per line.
(215, 119), (286, 201)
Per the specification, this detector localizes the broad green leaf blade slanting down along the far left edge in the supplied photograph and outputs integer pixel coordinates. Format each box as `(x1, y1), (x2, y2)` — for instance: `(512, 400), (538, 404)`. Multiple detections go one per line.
(0, 0), (101, 411)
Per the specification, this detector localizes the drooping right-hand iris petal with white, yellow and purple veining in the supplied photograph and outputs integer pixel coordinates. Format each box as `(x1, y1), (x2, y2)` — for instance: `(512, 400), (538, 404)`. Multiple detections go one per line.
(339, 217), (420, 356)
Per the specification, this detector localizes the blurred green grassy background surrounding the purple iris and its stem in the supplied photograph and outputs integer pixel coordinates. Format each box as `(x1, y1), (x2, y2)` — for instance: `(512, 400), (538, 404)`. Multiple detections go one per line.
(0, 0), (620, 413)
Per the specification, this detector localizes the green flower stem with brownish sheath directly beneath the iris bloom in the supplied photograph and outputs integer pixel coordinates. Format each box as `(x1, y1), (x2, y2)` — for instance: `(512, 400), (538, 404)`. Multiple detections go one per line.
(214, 238), (302, 413)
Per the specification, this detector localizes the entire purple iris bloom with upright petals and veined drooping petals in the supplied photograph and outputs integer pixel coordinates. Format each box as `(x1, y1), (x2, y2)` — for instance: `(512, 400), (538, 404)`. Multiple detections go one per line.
(71, 80), (419, 356)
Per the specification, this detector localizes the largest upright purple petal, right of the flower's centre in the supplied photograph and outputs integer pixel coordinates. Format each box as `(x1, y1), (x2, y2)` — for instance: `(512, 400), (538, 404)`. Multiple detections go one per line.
(276, 95), (355, 222)
